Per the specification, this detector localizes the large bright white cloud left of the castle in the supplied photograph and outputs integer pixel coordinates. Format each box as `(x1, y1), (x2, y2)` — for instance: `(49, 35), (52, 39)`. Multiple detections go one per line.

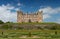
(0, 4), (19, 22)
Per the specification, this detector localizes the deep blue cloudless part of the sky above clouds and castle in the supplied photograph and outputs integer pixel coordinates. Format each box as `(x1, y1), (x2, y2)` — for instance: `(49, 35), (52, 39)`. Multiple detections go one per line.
(0, 0), (60, 12)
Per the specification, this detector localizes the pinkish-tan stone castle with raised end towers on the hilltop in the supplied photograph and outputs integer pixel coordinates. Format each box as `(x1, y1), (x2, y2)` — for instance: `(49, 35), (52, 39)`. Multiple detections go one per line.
(17, 11), (43, 23)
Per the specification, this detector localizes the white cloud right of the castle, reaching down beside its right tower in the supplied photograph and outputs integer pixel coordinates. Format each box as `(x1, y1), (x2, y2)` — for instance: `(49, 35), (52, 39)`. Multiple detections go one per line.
(39, 6), (60, 19)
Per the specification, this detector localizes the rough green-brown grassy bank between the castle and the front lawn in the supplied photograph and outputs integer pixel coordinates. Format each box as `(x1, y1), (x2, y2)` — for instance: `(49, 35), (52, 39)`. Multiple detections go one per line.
(0, 22), (60, 30)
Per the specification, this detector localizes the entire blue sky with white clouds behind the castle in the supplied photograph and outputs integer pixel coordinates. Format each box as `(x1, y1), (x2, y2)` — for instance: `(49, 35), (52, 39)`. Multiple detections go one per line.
(0, 0), (60, 23)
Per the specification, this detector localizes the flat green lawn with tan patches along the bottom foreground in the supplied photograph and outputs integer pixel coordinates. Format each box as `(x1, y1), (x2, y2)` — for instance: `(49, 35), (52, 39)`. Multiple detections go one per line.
(0, 30), (60, 39)
